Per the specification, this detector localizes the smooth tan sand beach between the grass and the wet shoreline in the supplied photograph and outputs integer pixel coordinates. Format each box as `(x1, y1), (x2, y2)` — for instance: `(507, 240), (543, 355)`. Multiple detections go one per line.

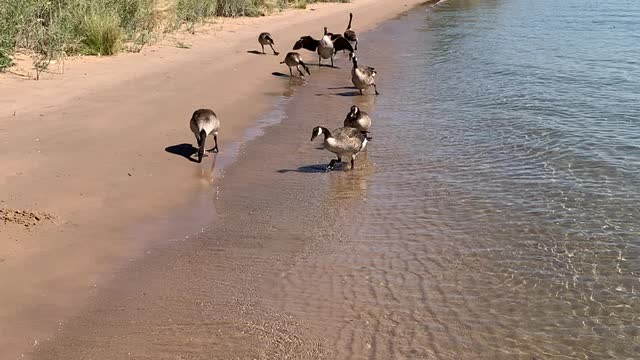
(0, 0), (430, 359)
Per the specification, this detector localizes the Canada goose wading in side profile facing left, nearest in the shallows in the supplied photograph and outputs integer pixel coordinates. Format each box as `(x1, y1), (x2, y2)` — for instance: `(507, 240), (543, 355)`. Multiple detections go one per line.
(311, 126), (367, 171)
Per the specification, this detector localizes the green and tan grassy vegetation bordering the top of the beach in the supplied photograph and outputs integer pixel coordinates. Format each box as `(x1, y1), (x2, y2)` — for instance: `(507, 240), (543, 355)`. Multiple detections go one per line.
(0, 0), (349, 78)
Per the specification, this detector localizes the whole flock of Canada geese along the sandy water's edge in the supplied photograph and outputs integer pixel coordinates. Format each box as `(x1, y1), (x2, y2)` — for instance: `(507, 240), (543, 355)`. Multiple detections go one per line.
(189, 13), (379, 171)
